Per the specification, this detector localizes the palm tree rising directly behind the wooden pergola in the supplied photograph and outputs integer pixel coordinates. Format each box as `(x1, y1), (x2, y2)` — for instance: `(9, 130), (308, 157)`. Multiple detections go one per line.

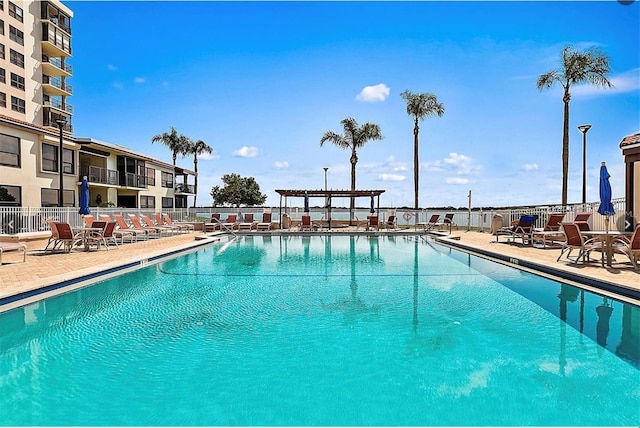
(320, 117), (383, 224)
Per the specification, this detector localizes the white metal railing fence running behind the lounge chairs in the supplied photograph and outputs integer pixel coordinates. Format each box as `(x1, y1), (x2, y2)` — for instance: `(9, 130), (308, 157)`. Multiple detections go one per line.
(0, 198), (626, 235)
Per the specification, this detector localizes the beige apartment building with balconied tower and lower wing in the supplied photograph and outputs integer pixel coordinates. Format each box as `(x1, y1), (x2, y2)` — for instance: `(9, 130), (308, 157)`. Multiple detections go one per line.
(0, 0), (195, 209)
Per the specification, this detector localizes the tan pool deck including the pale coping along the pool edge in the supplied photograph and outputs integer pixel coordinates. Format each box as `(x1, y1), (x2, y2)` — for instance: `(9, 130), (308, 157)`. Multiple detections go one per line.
(0, 228), (640, 309)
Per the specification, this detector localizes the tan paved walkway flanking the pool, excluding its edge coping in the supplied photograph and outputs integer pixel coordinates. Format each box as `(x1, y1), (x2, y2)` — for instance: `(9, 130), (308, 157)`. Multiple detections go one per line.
(0, 228), (640, 308)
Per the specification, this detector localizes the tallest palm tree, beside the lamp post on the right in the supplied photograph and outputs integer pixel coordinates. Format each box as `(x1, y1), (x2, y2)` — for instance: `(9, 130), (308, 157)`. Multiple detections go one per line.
(537, 46), (612, 206)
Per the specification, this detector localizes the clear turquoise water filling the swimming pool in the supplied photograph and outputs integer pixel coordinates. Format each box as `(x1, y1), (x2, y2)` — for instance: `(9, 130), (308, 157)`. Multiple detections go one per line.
(0, 236), (640, 426)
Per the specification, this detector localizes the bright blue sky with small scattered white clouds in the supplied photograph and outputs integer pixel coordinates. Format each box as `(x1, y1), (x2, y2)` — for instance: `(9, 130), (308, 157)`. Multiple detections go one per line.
(65, 1), (640, 207)
